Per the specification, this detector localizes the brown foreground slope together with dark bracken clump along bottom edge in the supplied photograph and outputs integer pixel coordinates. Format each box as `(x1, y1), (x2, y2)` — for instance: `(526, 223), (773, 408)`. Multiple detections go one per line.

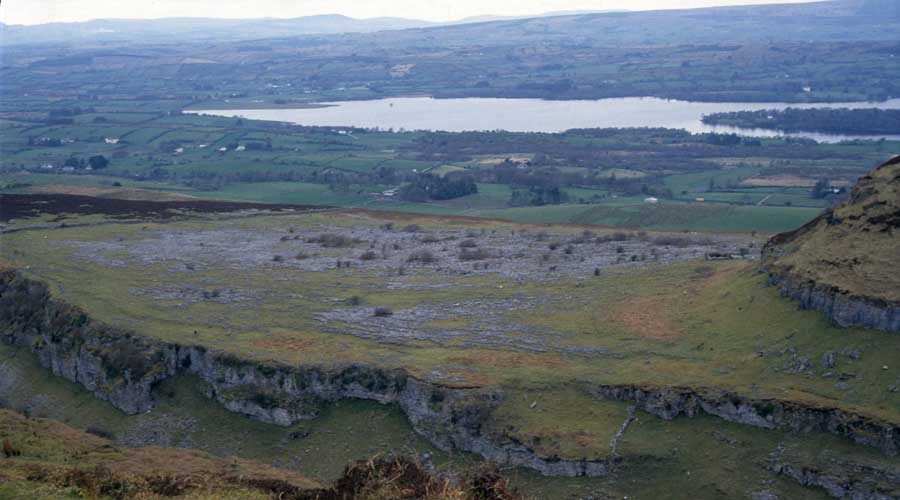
(0, 409), (522, 500)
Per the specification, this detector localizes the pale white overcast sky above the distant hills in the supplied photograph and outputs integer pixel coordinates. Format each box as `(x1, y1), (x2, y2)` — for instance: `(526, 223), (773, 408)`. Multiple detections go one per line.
(0, 0), (824, 24)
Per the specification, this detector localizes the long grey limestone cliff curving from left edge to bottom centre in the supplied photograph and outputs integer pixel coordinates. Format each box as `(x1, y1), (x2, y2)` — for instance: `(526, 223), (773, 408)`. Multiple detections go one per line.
(0, 271), (609, 476)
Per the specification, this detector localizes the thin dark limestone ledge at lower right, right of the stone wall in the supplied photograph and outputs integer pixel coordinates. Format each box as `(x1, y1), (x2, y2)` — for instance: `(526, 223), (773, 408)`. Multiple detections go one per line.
(595, 385), (900, 455)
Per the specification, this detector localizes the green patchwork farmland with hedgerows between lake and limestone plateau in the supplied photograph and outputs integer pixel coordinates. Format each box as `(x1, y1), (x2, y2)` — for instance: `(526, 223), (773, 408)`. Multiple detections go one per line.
(0, 100), (896, 233)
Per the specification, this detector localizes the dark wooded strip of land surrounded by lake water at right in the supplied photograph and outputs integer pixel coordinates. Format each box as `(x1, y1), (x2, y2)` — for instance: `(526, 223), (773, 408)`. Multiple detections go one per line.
(703, 108), (900, 135)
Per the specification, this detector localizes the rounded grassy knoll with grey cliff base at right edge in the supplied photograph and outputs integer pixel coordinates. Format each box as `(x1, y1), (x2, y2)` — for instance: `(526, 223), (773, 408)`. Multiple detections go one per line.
(761, 157), (900, 332)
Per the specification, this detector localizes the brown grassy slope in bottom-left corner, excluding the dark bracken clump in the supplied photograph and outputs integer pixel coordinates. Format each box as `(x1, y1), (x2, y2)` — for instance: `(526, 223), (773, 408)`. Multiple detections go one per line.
(0, 409), (320, 499)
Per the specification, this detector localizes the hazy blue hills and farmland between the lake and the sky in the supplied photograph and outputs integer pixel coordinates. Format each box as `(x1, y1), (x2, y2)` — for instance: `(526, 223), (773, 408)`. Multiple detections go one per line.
(7, 0), (900, 106)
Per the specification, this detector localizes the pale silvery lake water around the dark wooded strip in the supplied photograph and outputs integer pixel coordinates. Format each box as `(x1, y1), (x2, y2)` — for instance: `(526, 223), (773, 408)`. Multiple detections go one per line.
(187, 97), (900, 142)
